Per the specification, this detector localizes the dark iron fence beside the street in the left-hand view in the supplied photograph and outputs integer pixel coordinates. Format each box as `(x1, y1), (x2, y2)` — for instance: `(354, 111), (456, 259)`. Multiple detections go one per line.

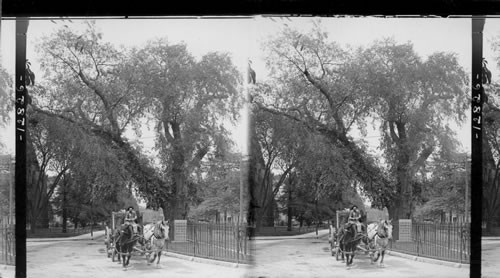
(166, 223), (252, 264)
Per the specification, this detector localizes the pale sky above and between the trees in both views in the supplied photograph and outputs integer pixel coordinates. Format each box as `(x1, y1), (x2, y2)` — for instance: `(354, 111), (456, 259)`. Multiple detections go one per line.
(0, 16), (488, 160)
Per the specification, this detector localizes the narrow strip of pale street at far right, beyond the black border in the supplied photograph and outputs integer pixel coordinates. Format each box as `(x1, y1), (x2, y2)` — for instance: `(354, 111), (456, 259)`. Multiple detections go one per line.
(481, 238), (500, 278)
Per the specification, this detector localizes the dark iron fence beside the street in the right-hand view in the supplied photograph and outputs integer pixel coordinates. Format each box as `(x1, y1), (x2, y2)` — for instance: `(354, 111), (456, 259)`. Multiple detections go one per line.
(390, 222), (470, 264)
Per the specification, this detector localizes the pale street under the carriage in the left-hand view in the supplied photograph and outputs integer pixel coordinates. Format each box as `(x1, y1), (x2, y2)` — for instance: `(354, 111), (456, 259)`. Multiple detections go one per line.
(26, 235), (246, 278)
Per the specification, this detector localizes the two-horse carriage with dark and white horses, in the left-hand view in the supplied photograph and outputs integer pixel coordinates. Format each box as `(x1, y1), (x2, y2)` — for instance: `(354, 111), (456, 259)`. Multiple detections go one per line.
(104, 211), (169, 267)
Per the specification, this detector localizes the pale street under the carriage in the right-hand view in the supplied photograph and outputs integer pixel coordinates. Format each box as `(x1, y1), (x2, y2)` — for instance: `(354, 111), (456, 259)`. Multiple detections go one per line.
(249, 237), (470, 278)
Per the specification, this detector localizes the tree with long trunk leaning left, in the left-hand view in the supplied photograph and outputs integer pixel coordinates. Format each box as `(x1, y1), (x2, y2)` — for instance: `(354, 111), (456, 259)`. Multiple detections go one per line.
(32, 22), (170, 222)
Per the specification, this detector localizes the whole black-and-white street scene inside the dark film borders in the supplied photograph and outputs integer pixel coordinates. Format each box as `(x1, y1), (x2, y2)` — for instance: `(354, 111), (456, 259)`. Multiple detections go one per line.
(0, 16), (482, 278)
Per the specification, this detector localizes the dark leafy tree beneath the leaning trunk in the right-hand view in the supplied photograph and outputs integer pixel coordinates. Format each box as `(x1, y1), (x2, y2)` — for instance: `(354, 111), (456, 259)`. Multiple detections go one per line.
(278, 134), (364, 229)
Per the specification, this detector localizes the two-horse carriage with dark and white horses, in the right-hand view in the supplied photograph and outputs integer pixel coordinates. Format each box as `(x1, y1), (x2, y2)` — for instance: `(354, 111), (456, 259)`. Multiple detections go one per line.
(329, 210), (392, 266)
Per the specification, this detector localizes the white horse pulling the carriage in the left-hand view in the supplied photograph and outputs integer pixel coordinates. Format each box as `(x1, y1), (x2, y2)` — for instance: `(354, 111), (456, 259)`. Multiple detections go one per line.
(144, 220), (170, 267)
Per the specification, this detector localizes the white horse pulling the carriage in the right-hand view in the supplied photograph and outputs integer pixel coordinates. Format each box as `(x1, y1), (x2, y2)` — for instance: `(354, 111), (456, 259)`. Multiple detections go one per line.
(368, 220), (392, 267)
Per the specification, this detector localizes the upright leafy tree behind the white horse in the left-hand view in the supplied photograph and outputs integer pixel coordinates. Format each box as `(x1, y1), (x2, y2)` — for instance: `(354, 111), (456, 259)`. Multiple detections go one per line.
(128, 39), (240, 222)
